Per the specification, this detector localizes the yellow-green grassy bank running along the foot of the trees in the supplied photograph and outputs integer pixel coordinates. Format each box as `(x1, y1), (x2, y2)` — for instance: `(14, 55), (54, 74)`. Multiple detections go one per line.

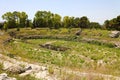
(8, 28), (120, 42)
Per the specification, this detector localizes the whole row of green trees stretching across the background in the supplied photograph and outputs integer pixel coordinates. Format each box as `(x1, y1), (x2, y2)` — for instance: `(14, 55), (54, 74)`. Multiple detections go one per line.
(0, 11), (120, 30)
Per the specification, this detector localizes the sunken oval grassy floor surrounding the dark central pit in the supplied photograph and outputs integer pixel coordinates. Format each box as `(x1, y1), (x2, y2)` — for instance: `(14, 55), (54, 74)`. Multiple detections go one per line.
(5, 39), (120, 75)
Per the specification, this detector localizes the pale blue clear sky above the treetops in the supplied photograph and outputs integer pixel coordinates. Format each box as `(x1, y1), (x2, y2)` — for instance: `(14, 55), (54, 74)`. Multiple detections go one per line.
(0, 0), (120, 24)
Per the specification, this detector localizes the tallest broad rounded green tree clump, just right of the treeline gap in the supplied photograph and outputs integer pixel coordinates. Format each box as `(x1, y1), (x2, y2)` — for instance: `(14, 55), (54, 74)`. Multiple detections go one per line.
(33, 11), (61, 29)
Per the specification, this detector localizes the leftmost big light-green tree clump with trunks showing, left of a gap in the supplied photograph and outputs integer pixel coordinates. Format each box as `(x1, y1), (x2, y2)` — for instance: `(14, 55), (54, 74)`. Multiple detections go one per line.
(2, 11), (28, 30)
